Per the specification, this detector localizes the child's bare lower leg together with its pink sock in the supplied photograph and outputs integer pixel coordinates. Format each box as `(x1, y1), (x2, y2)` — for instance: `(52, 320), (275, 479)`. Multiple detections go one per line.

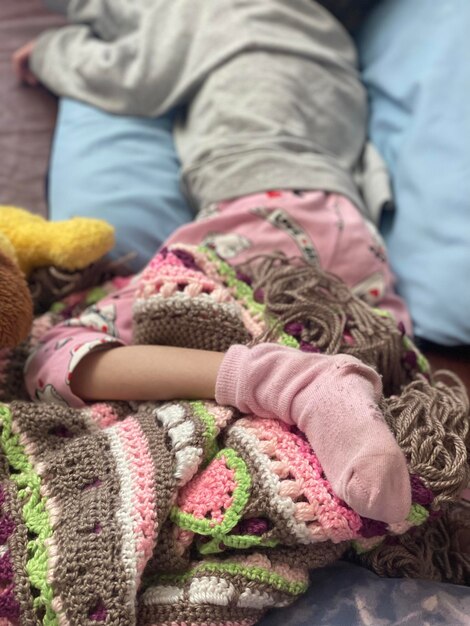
(71, 344), (411, 523)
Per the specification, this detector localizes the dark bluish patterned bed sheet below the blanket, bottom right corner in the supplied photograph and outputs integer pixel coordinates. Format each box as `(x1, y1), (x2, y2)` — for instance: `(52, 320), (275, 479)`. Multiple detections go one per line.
(260, 562), (470, 626)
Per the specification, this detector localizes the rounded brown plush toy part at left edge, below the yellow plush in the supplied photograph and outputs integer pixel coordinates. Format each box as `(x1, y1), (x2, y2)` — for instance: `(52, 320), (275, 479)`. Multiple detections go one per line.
(0, 250), (33, 348)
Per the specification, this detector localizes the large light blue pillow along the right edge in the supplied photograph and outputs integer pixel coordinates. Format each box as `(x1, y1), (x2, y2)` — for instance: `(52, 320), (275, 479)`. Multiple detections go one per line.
(358, 0), (470, 345)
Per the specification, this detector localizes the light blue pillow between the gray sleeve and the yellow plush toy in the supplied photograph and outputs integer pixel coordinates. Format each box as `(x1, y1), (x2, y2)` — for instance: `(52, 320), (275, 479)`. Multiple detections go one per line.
(48, 98), (194, 271)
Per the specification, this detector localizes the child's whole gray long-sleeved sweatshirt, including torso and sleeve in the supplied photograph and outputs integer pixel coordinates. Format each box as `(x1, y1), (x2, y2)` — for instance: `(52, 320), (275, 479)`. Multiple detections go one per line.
(31, 0), (378, 210)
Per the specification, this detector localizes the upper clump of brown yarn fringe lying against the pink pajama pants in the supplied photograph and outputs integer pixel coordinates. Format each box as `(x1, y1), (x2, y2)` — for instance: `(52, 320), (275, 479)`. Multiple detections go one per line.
(239, 254), (411, 395)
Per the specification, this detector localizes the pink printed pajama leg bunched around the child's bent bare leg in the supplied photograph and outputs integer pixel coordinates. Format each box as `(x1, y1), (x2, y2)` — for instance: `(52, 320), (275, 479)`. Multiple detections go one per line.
(25, 276), (135, 407)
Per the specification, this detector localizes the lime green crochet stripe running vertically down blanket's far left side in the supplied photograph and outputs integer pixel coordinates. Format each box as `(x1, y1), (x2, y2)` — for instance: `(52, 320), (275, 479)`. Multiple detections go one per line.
(0, 405), (59, 626)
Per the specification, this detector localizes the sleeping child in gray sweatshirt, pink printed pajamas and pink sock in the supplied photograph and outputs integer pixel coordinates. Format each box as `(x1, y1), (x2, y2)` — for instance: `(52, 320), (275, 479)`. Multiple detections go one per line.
(16, 0), (411, 523)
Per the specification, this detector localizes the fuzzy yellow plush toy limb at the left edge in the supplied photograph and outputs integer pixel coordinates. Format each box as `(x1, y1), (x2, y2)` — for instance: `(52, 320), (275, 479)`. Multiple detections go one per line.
(0, 206), (114, 277)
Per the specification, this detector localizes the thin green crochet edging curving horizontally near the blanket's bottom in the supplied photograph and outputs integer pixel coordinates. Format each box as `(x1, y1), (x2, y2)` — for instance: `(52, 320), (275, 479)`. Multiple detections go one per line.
(156, 562), (308, 596)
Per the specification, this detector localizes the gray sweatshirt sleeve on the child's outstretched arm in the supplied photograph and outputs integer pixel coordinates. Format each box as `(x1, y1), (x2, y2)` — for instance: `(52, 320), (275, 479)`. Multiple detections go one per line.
(30, 0), (230, 117)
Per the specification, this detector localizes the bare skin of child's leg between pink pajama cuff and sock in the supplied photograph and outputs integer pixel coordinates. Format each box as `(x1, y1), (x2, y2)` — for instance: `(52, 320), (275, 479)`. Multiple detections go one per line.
(70, 345), (224, 401)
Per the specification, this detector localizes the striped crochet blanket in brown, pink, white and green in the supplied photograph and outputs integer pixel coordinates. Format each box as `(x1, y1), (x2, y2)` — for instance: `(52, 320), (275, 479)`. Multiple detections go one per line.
(0, 246), (470, 626)
